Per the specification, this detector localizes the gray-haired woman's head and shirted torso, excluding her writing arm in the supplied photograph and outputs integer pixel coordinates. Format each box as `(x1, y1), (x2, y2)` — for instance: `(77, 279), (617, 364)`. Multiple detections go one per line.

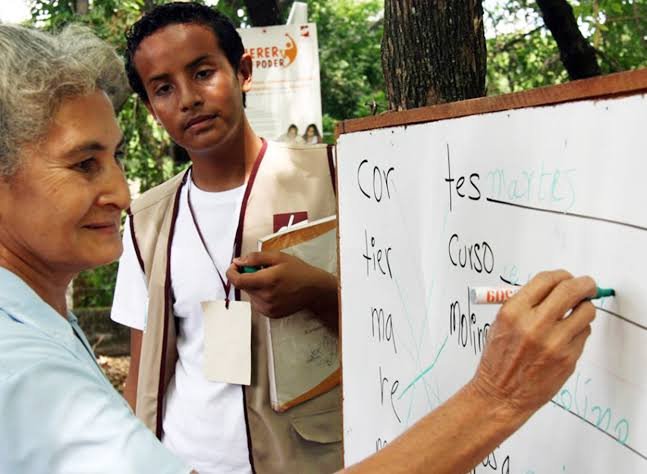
(0, 25), (190, 474)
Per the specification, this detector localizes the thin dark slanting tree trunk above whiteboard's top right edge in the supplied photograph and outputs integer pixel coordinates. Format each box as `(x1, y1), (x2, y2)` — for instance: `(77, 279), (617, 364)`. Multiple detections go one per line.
(537, 0), (600, 80)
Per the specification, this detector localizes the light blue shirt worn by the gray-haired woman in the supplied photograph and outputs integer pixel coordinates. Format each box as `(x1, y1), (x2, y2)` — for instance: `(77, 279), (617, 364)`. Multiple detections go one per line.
(0, 268), (191, 474)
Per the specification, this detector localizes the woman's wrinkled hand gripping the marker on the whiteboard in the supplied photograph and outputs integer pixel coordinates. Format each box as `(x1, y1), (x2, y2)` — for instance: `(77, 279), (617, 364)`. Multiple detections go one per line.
(469, 270), (595, 417)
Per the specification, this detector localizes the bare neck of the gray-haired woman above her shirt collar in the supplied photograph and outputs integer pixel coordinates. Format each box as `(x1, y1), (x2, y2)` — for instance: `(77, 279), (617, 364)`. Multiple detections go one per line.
(0, 244), (75, 318)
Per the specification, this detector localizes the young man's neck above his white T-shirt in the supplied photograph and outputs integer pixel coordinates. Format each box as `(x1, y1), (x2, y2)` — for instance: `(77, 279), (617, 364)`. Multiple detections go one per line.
(190, 119), (263, 192)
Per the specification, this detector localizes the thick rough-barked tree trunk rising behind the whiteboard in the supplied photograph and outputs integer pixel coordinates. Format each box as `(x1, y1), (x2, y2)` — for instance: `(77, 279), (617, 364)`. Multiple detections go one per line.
(382, 0), (486, 110)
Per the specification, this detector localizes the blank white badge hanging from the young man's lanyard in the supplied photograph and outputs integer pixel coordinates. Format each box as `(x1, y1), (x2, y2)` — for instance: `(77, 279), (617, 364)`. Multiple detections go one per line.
(200, 300), (252, 385)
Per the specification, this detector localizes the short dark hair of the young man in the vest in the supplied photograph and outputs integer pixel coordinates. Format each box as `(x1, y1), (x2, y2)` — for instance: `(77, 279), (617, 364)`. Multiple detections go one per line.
(126, 2), (245, 101)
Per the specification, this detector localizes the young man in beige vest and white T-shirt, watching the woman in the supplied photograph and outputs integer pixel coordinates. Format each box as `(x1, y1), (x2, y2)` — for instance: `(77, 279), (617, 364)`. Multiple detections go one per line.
(112, 2), (341, 473)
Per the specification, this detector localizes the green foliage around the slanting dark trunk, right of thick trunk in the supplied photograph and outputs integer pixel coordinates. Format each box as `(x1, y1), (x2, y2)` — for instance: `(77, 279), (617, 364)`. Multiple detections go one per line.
(484, 0), (647, 95)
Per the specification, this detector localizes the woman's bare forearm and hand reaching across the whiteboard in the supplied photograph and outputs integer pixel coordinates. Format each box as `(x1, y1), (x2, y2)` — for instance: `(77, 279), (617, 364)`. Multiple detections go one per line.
(343, 271), (595, 474)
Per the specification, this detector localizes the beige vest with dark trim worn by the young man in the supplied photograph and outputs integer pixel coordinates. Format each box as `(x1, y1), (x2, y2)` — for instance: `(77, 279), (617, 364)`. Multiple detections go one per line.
(131, 143), (342, 474)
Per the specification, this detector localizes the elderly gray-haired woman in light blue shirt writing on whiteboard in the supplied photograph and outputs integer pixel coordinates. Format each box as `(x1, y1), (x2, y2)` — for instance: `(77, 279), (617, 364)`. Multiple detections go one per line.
(0, 25), (595, 474)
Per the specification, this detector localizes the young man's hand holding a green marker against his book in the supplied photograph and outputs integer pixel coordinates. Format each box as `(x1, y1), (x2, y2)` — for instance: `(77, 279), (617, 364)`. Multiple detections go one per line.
(227, 251), (337, 327)
